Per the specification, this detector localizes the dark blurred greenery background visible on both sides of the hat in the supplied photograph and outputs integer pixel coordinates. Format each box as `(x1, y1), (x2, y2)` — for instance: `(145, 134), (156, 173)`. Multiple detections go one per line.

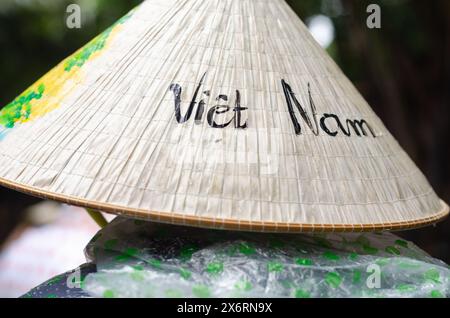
(0, 0), (450, 263)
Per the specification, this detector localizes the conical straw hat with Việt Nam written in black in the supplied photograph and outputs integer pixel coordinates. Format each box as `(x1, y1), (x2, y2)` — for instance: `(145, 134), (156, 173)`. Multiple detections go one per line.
(0, 0), (448, 232)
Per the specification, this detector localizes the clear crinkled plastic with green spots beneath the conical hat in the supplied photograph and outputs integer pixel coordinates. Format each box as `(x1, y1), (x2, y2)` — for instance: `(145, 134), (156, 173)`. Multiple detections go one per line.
(75, 217), (450, 298)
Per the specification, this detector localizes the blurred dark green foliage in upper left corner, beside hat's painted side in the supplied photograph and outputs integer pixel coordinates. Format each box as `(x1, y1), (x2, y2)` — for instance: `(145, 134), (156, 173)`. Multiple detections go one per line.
(0, 0), (141, 106)
